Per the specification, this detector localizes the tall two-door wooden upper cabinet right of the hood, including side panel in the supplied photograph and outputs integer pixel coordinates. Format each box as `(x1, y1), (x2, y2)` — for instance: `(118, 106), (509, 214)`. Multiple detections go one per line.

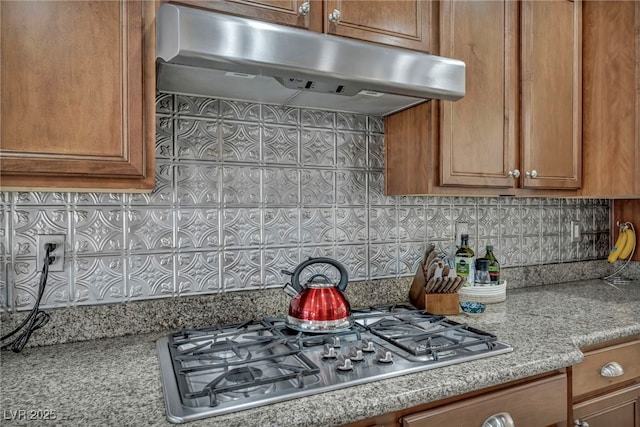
(385, 0), (582, 195)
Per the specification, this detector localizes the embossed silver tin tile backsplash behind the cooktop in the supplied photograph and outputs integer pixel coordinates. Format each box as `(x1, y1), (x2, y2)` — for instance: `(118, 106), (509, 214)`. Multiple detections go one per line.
(0, 94), (610, 311)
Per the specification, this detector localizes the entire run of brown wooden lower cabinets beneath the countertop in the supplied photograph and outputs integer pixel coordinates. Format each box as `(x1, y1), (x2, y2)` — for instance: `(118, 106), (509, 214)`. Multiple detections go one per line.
(347, 335), (640, 427)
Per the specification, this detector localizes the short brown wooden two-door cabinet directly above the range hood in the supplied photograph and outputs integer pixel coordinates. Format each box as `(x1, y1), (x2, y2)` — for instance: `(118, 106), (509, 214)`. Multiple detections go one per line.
(171, 0), (431, 52)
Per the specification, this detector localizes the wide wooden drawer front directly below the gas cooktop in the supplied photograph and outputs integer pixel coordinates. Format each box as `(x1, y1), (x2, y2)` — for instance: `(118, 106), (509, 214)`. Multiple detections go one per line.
(401, 374), (567, 427)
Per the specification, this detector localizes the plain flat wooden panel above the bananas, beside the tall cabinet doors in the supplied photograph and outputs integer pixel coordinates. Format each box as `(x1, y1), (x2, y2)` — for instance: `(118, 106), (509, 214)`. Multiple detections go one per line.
(581, 1), (640, 198)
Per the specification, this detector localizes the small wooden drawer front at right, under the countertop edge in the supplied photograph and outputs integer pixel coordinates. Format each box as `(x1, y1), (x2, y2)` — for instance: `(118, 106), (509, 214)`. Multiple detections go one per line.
(573, 340), (640, 397)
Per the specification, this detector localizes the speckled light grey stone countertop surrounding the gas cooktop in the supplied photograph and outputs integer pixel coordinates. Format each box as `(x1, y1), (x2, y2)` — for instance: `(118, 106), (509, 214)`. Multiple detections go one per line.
(0, 280), (640, 426)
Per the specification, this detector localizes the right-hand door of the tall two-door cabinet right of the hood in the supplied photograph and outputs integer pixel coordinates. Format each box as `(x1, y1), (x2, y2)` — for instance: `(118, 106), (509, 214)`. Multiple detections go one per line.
(521, 0), (582, 189)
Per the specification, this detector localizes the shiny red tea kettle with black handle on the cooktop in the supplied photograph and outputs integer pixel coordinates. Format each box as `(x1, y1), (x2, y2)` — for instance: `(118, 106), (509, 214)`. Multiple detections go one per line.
(282, 257), (353, 332)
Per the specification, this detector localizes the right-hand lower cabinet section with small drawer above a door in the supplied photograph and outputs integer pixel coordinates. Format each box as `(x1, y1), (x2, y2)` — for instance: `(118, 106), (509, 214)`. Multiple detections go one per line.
(572, 337), (640, 427)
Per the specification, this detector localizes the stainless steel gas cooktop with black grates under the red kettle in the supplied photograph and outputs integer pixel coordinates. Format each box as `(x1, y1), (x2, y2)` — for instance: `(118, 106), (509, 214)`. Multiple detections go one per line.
(157, 306), (512, 423)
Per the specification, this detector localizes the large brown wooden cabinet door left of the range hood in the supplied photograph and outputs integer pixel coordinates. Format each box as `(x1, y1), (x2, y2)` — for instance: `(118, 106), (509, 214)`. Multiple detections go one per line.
(0, 0), (155, 190)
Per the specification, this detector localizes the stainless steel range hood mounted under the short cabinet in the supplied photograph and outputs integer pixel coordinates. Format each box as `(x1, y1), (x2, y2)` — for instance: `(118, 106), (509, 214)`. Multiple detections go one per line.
(156, 4), (465, 116)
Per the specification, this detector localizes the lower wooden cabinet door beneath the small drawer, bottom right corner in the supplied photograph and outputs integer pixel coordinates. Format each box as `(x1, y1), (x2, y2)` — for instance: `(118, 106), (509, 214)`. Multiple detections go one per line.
(573, 384), (640, 427)
